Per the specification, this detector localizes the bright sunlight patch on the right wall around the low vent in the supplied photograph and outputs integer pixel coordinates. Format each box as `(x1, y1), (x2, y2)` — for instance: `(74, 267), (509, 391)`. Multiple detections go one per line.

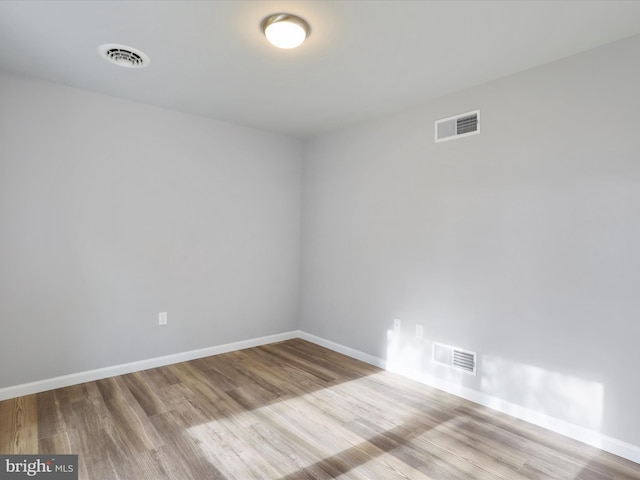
(387, 330), (604, 432)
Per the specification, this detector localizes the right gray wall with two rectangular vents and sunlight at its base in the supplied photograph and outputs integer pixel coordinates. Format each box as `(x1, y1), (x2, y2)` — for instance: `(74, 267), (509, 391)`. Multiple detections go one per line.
(300, 37), (640, 445)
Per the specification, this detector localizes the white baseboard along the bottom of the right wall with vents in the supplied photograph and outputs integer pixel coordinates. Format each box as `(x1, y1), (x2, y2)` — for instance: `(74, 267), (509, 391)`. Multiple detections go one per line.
(299, 332), (640, 463)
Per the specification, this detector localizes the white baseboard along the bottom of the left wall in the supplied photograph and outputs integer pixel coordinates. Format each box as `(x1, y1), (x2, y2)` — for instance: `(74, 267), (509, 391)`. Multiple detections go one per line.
(0, 330), (299, 401)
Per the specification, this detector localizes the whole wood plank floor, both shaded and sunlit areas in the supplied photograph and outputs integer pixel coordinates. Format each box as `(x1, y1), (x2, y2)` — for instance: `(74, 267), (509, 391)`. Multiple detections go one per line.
(0, 340), (640, 480)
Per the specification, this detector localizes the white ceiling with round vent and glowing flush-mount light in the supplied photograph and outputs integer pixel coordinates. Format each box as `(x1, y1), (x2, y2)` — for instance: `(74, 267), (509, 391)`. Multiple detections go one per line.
(0, 0), (640, 137)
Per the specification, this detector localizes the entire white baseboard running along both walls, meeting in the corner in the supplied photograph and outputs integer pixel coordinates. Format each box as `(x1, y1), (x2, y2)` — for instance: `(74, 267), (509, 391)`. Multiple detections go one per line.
(0, 330), (640, 463)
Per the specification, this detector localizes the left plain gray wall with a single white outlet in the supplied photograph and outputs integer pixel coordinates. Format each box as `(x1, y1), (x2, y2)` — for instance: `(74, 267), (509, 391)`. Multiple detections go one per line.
(0, 75), (300, 387)
